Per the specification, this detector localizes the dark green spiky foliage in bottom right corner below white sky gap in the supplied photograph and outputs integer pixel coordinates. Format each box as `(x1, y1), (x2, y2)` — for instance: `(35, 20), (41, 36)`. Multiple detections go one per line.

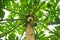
(49, 25), (60, 40)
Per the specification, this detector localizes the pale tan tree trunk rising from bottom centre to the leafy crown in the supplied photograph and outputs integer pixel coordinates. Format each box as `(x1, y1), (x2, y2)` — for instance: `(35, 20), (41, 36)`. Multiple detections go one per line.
(26, 23), (34, 40)
